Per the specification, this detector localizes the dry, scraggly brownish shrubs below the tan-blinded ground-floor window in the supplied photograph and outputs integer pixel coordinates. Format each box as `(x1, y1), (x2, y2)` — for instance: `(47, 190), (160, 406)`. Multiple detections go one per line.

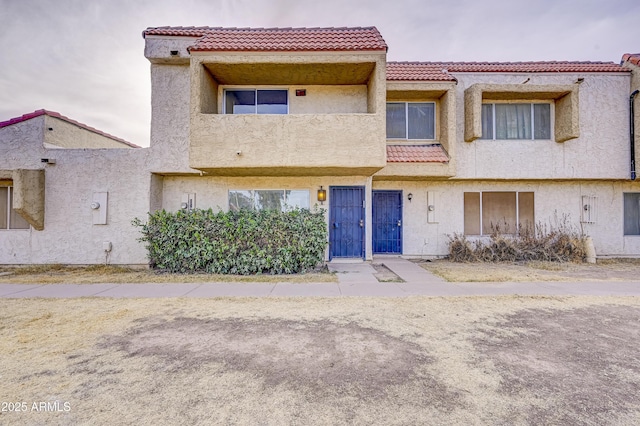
(449, 216), (586, 262)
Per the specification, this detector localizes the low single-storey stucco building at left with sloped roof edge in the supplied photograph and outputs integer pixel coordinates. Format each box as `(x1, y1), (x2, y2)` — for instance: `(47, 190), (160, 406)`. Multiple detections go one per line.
(0, 110), (151, 264)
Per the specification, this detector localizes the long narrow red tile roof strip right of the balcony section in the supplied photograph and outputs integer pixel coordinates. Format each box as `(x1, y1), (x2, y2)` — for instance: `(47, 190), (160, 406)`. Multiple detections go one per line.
(387, 61), (629, 81)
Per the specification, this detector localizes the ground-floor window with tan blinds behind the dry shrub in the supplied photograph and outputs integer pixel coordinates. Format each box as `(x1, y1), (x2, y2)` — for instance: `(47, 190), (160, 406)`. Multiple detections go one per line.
(464, 192), (535, 235)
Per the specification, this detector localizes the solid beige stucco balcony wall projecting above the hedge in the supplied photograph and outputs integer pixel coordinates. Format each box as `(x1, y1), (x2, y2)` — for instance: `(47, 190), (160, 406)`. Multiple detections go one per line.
(189, 113), (386, 176)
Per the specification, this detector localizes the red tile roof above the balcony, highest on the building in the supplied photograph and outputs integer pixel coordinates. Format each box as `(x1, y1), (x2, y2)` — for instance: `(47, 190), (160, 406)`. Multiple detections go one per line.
(143, 27), (387, 52)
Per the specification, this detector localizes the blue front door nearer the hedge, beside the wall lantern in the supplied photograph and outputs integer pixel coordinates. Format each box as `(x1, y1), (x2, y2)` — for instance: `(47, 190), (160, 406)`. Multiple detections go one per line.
(329, 186), (365, 258)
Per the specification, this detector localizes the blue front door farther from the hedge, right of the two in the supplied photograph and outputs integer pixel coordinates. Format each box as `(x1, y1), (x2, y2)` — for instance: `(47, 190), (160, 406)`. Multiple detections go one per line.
(372, 191), (402, 254)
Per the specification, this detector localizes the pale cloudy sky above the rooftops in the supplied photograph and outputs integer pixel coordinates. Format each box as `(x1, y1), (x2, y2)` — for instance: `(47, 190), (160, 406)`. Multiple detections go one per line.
(0, 0), (640, 146)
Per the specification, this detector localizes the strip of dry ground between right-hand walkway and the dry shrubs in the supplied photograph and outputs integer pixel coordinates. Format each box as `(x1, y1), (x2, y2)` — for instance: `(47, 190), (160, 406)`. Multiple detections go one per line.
(416, 259), (640, 282)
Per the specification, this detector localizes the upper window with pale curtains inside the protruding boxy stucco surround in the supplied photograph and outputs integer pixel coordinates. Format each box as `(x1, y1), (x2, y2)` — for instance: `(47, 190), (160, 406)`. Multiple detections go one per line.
(481, 103), (551, 139)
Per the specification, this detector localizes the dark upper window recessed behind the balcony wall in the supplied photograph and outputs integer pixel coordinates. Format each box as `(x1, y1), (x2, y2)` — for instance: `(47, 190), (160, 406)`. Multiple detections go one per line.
(224, 89), (289, 114)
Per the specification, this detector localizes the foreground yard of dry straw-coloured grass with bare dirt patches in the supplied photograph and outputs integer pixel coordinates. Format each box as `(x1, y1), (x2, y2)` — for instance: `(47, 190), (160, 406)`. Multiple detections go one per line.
(0, 296), (640, 425)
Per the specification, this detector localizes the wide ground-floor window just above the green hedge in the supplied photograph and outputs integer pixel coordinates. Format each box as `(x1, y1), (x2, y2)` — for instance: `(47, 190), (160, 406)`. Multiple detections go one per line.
(229, 189), (309, 211)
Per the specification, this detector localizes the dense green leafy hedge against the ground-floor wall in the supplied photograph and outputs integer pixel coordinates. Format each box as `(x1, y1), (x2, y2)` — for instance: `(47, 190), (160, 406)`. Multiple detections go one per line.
(133, 209), (327, 275)
